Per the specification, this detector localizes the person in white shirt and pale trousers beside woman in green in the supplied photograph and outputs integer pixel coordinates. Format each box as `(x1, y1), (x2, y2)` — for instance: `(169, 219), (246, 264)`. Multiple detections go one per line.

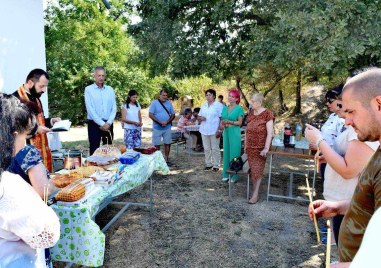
(198, 89), (224, 172)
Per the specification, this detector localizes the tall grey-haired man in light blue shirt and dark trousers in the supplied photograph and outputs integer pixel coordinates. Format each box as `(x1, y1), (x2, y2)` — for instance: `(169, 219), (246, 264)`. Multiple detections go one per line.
(85, 66), (116, 155)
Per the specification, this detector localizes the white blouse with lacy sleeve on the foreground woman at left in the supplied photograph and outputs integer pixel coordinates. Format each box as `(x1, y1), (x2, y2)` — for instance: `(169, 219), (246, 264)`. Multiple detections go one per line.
(0, 172), (60, 267)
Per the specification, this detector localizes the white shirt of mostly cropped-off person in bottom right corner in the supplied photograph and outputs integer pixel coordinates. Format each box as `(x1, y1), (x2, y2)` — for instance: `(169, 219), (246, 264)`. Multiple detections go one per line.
(349, 208), (381, 268)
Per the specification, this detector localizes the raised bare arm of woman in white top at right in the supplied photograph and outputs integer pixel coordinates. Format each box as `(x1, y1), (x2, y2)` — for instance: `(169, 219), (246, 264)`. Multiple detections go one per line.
(305, 124), (374, 179)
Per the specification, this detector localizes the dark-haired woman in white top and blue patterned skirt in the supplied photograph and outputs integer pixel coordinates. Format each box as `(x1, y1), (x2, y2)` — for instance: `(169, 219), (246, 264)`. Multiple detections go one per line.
(122, 89), (143, 149)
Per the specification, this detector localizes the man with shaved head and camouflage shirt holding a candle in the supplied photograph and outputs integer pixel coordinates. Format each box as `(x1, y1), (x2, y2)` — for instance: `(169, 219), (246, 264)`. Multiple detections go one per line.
(308, 68), (381, 268)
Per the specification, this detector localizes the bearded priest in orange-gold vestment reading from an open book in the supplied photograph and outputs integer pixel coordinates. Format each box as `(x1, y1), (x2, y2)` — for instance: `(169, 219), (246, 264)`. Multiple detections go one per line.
(13, 69), (61, 172)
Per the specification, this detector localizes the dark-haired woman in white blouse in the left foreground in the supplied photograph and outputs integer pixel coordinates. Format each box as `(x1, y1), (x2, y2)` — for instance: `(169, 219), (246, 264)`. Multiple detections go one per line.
(0, 94), (60, 267)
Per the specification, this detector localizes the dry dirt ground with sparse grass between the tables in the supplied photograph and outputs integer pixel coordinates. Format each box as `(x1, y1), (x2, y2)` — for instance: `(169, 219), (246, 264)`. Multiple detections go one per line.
(55, 118), (336, 268)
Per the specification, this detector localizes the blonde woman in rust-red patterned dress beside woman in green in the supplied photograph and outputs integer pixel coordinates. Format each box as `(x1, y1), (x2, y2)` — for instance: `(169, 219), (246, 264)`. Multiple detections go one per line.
(245, 93), (274, 204)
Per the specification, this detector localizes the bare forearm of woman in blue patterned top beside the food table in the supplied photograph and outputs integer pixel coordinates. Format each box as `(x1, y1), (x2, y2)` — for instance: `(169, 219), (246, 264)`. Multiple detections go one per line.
(27, 162), (58, 198)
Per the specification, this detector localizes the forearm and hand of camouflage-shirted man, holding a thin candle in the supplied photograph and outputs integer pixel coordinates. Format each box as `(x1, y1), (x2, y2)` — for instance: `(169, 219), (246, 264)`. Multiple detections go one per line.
(308, 199), (351, 220)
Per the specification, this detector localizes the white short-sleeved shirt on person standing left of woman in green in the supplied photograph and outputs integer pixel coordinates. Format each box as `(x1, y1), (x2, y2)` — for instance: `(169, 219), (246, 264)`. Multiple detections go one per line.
(198, 101), (224, 135)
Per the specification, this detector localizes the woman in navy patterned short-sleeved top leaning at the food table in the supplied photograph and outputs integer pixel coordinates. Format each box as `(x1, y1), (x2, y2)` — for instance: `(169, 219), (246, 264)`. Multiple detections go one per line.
(0, 94), (57, 267)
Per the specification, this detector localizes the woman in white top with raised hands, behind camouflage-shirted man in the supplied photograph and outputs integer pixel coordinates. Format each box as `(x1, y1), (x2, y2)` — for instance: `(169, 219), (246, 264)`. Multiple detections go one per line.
(305, 95), (379, 246)
